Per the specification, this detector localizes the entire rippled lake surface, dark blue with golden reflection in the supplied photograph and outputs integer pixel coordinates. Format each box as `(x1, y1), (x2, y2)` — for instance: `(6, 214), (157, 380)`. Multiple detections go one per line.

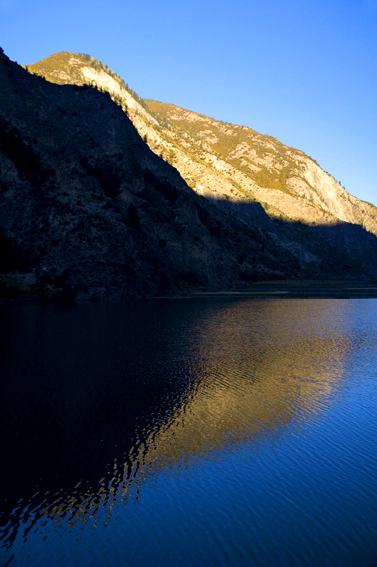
(0, 299), (377, 567)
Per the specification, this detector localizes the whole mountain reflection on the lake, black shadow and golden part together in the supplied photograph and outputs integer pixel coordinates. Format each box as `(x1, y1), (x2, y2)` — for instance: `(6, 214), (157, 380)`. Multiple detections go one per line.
(0, 300), (375, 560)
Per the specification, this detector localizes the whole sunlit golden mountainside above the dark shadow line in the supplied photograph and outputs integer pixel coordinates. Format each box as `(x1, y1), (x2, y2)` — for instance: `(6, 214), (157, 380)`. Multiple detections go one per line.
(28, 52), (377, 235)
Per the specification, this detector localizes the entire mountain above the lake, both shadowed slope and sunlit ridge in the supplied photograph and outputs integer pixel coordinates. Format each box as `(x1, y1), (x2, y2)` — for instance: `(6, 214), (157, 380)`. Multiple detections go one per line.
(0, 52), (377, 299)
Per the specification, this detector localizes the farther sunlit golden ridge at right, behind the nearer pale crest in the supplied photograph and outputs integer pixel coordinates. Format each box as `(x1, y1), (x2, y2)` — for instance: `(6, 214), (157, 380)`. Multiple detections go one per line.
(146, 101), (377, 234)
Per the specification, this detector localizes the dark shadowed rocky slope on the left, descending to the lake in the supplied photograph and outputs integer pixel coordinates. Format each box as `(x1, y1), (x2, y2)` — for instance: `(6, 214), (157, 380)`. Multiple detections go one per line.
(0, 53), (306, 299)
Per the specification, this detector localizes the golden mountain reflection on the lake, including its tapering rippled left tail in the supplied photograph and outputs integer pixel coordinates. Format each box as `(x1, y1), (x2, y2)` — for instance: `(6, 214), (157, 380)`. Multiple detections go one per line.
(2, 301), (356, 544)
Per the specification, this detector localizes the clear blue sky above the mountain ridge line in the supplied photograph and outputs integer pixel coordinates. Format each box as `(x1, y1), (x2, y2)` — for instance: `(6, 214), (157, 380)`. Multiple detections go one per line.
(0, 0), (377, 205)
